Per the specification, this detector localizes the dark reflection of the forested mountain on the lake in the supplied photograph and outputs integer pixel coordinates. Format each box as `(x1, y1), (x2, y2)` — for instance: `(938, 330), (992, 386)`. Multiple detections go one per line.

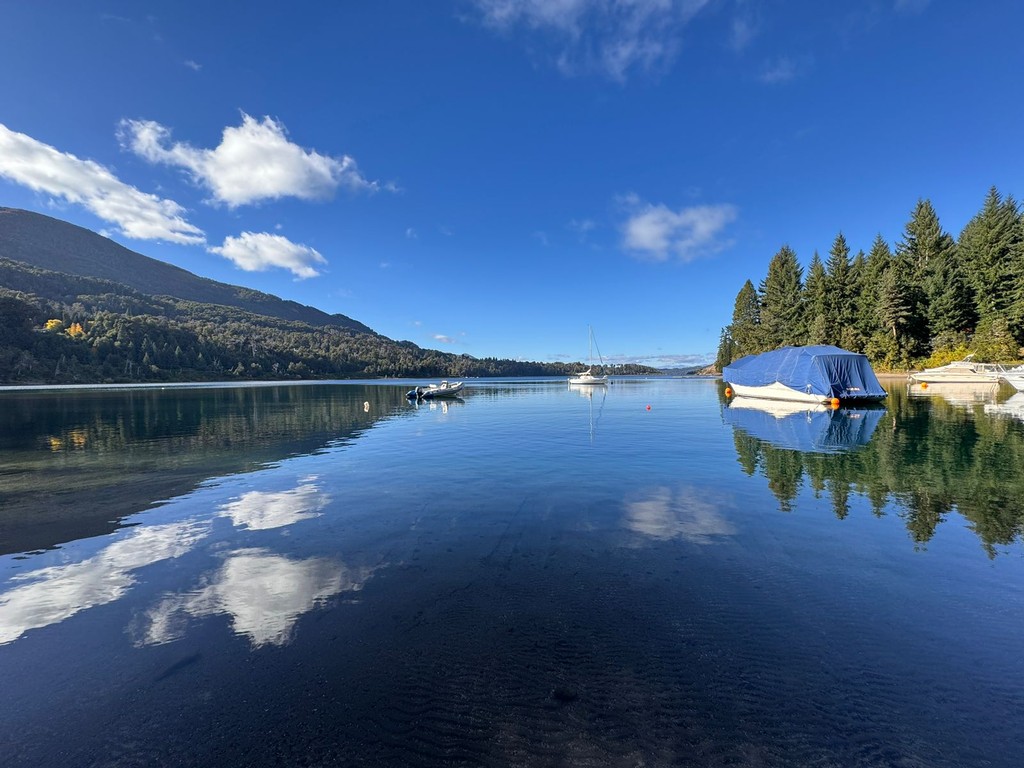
(0, 384), (404, 555)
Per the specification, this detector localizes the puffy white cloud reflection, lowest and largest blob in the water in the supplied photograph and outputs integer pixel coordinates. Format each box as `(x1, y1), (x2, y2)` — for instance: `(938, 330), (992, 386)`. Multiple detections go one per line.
(133, 549), (373, 648)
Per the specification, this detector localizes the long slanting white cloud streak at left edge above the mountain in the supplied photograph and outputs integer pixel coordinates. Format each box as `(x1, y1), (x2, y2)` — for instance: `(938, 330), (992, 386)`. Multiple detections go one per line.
(0, 124), (206, 244)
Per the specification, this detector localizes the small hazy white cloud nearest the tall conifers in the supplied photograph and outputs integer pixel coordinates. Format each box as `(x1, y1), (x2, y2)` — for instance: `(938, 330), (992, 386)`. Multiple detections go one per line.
(623, 196), (736, 261)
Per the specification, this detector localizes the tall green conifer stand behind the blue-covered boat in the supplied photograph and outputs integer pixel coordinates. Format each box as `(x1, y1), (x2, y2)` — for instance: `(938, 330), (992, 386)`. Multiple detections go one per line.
(715, 187), (1024, 371)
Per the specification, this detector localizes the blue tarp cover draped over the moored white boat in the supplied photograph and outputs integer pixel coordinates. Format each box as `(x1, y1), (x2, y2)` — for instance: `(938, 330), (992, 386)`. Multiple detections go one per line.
(722, 345), (886, 399)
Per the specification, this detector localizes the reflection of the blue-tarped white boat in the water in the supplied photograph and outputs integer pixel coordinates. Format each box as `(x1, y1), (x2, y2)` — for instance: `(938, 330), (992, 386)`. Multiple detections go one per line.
(723, 397), (886, 454)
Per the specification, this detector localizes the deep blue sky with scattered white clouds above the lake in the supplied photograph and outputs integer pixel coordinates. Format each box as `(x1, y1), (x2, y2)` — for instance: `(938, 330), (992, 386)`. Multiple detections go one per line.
(0, 0), (1024, 367)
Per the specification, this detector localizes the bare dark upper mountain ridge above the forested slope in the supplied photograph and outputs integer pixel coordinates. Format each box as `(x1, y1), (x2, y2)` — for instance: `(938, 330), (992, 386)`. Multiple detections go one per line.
(0, 208), (376, 335)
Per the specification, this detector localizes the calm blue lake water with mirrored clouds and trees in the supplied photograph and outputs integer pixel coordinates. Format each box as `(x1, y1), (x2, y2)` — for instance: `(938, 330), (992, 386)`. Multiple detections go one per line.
(0, 379), (1024, 768)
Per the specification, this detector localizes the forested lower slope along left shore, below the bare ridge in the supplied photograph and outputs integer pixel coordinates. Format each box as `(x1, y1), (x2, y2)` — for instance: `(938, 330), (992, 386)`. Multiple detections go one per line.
(0, 258), (656, 384)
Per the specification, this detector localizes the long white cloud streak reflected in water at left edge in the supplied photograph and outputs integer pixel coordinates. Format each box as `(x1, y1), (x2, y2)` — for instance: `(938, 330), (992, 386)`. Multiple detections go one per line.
(0, 520), (209, 645)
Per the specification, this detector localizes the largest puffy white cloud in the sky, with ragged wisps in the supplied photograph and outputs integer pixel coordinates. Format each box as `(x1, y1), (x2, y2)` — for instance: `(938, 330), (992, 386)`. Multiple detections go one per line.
(119, 113), (380, 208)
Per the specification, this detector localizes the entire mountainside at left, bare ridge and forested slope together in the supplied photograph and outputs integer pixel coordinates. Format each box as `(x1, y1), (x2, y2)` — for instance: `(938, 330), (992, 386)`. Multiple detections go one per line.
(0, 208), (663, 384)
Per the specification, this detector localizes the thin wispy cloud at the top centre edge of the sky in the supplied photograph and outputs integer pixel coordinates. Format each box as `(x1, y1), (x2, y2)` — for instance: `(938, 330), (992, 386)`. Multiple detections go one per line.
(471, 0), (710, 82)
